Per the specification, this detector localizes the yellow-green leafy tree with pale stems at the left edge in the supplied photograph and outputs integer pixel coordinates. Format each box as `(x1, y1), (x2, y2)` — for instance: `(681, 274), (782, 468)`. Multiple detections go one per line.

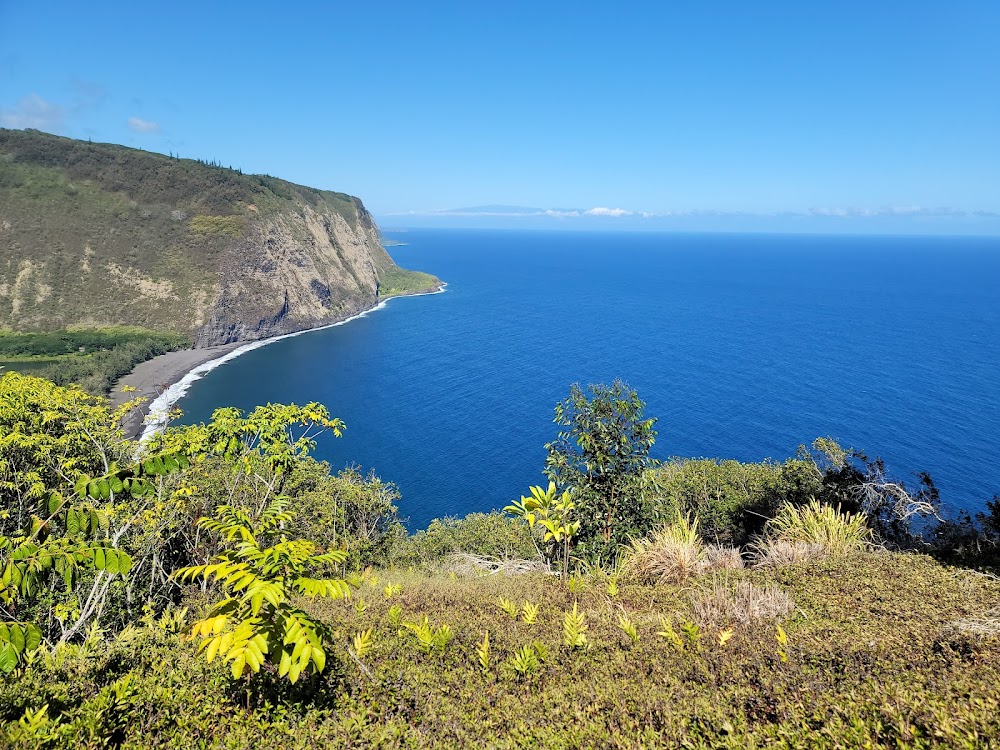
(0, 373), (188, 671)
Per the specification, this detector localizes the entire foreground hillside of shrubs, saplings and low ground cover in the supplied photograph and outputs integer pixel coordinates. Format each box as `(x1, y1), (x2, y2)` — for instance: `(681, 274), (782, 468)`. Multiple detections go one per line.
(0, 372), (1000, 748)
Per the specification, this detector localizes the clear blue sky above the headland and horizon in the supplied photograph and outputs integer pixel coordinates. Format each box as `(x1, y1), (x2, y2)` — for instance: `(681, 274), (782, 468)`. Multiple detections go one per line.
(0, 0), (1000, 233)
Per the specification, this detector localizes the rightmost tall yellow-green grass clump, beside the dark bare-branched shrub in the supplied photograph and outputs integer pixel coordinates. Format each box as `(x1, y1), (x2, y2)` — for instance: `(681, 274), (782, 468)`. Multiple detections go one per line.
(755, 498), (874, 565)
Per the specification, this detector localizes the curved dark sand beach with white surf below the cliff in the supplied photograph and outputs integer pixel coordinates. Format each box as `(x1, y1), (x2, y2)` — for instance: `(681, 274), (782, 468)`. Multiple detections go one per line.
(115, 282), (448, 442)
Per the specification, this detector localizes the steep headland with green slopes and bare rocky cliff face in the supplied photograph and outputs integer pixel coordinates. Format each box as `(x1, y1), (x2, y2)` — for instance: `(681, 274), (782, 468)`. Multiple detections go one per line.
(0, 129), (438, 346)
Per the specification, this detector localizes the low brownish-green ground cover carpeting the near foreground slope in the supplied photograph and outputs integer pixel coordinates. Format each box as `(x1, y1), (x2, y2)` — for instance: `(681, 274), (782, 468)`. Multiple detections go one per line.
(0, 553), (1000, 748)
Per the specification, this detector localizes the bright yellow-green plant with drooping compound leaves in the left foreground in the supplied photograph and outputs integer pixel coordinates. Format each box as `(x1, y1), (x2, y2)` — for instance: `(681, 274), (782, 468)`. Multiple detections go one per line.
(174, 499), (350, 682)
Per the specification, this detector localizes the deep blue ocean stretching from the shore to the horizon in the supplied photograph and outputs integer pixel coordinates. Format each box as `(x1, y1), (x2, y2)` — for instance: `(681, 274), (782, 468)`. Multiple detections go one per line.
(179, 230), (1000, 529)
